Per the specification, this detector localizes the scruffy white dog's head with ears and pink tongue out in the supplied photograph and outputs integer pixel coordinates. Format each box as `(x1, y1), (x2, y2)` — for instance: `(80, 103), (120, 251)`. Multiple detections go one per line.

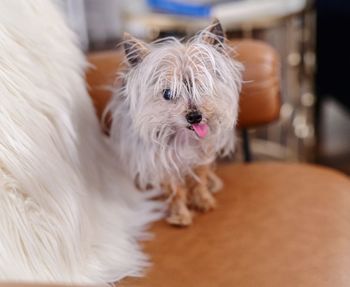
(119, 21), (241, 151)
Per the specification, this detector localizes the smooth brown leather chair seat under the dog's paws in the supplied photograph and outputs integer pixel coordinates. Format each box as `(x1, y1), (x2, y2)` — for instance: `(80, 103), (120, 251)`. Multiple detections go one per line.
(119, 163), (350, 287)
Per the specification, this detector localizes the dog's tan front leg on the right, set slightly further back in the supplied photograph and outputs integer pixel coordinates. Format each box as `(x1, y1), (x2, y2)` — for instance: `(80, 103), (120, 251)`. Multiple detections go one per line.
(187, 165), (216, 211)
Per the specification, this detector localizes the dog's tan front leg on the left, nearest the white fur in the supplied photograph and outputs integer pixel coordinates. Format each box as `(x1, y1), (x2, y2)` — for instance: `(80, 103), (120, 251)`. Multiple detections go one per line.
(163, 185), (192, 226)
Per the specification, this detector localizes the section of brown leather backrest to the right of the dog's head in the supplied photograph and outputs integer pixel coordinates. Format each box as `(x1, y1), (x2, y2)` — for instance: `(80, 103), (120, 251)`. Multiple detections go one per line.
(231, 39), (280, 128)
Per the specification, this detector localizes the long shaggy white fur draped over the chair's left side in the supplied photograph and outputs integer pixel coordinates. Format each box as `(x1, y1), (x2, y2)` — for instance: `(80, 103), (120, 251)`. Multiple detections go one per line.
(0, 0), (158, 284)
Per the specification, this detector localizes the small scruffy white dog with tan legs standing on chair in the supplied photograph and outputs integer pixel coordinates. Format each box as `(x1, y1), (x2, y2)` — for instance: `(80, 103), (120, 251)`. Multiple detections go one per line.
(107, 20), (242, 225)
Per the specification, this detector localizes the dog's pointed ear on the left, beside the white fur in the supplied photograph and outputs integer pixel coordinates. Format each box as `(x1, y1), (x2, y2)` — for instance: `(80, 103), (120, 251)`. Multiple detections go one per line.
(123, 33), (149, 66)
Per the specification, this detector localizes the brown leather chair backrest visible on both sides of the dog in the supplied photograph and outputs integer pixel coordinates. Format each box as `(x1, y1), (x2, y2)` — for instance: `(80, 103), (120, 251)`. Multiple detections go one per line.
(87, 40), (280, 128)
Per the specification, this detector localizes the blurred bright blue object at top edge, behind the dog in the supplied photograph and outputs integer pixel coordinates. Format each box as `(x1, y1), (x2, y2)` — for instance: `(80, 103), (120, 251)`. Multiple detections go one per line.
(147, 0), (211, 17)
